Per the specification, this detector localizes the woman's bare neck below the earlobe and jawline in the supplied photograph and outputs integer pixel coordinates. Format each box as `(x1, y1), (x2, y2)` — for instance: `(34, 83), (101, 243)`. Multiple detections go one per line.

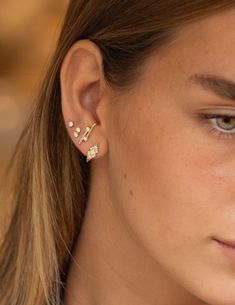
(65, 159), (207, 305)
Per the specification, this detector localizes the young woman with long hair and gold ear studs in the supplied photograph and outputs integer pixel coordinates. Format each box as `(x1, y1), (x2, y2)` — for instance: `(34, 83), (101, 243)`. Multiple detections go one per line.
(0, 0), (235, 305)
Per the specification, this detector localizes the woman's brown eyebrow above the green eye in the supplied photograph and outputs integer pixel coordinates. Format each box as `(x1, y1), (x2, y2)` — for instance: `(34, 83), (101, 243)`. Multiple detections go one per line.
(189, 74), (235, 102)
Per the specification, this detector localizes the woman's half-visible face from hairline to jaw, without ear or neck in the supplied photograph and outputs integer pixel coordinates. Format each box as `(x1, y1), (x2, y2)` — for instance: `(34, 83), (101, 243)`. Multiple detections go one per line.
(108, 10), (235, 305)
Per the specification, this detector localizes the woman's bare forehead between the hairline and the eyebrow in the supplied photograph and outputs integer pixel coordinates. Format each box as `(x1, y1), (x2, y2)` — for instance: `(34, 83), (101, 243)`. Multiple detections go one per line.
(141, 8), (235, 88)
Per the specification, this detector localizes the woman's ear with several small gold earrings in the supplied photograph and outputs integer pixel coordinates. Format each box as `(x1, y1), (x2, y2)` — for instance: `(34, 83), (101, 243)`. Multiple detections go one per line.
(60, 39), (108, 162)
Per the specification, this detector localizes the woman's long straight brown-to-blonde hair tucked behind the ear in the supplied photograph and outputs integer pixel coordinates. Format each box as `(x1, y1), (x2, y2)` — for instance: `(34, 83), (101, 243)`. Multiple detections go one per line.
(0, 0), (234, 305)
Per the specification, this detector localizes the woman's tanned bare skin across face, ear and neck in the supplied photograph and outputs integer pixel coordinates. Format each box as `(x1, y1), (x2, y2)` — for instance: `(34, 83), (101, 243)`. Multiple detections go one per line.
(61, 9), (235, 305)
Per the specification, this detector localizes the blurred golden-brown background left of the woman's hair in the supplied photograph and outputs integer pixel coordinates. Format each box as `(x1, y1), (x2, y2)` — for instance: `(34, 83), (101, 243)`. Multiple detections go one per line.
(0, 0), (69, 184)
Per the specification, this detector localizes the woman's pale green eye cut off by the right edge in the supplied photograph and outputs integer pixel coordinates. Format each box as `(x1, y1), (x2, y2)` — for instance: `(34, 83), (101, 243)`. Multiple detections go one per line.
(202, 113), (235, 138)
